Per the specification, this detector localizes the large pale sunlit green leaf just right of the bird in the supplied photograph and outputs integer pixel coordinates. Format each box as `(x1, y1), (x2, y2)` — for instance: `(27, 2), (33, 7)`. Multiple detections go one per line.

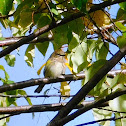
(68, 34), (89, 73)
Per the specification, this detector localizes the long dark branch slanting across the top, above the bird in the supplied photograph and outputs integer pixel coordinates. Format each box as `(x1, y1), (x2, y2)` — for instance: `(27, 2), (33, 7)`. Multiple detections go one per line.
(0, 0), (125, 58)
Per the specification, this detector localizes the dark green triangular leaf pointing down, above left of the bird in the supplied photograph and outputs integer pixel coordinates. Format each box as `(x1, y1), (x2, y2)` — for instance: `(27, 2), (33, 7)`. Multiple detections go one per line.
(36, 42), (49, 56)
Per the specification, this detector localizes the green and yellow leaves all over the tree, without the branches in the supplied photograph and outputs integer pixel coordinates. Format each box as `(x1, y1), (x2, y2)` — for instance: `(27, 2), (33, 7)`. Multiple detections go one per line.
(0, 0), (126, 126)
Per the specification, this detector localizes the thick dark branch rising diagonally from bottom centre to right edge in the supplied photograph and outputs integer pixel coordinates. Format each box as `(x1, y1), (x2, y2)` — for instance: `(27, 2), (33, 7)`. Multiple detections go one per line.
(49, 46), (126, 126)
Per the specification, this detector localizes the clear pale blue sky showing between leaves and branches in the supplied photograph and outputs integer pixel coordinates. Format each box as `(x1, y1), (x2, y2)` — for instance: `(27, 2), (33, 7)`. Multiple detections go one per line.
(0, 2), (122, 126)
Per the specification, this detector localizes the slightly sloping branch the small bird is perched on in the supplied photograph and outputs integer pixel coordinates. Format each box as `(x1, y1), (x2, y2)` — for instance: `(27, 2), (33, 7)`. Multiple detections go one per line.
(0, 70), (126, 93)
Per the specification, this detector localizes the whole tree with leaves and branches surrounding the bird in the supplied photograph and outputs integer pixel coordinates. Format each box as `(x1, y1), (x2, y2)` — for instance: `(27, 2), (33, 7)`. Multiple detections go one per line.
(0, 0), (126, 126)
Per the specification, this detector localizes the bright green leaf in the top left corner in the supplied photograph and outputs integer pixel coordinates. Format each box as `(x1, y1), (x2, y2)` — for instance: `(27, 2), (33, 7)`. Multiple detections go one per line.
(0, 0), (13, 15)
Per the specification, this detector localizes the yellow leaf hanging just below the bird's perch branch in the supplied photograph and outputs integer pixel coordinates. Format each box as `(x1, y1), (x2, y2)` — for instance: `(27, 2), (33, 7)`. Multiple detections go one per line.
(60, 81), (70, 100)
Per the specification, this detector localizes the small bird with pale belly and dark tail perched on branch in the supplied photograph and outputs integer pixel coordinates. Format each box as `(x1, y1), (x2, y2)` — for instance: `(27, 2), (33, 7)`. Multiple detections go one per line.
(35, 49), (66, 93)
